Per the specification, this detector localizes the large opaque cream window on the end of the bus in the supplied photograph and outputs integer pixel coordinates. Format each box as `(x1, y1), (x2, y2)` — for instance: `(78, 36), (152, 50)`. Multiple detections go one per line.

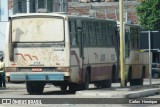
(12, 17), (64, 42)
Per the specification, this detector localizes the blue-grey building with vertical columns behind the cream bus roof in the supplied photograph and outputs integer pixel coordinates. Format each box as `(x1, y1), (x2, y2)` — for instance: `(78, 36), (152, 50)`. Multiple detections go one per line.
(12, 0), (67, 14)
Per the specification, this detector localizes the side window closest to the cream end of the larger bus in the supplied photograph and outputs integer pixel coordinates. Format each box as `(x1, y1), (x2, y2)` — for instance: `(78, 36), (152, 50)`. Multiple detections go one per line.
(69, 20), (78, 46)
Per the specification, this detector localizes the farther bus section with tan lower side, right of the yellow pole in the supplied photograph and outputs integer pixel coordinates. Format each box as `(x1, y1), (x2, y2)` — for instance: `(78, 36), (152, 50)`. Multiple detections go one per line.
(118, 23), (148, 86)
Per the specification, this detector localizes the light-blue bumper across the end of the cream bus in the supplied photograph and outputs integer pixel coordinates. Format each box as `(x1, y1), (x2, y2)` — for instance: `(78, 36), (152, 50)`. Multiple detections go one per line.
(10, 72), (69, 81)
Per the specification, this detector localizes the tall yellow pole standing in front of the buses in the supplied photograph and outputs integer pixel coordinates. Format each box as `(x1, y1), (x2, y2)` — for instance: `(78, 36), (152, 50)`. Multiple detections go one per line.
(119, 0), (125, 87)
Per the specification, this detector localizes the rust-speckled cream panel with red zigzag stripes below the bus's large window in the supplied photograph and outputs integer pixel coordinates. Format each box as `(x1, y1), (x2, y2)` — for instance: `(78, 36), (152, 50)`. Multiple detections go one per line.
(11, 47), (69, 67)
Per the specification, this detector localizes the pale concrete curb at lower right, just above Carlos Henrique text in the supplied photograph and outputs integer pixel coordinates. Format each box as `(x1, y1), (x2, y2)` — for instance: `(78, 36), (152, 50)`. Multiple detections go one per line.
(124, 88), (160, 99)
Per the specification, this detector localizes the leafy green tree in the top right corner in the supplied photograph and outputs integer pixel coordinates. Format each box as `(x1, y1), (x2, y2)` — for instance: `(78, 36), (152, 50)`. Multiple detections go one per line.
(136, 0), (160, 30)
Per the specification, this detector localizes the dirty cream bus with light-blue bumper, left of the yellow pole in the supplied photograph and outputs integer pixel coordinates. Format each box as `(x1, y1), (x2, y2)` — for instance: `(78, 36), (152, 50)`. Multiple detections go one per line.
(5, 13), (119, 94)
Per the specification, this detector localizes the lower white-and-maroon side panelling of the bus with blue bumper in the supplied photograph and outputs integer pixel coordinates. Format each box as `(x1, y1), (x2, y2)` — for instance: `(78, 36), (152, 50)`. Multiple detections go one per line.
(71, 48), (117, 82)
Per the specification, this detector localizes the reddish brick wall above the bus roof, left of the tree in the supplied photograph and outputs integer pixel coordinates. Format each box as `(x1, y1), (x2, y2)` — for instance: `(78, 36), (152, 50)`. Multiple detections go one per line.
(68, 1), (139, 24)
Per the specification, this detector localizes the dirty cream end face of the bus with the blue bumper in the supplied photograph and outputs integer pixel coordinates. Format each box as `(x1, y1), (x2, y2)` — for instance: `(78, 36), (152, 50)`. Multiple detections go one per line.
(5, 14), (70, 81)
